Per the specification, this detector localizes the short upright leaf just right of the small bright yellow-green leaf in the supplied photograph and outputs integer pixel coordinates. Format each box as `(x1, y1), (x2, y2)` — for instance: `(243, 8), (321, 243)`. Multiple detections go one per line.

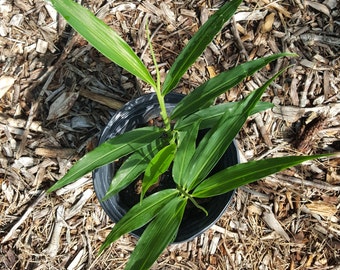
(172, 120), (200, 186)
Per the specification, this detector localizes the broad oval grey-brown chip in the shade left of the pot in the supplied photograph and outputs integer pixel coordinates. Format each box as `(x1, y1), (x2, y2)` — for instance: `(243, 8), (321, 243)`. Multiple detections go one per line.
(47, 92), (79, 120)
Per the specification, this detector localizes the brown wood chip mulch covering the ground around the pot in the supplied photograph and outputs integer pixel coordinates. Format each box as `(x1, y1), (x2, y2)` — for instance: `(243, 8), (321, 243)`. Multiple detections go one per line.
(0, 0), (340, 270)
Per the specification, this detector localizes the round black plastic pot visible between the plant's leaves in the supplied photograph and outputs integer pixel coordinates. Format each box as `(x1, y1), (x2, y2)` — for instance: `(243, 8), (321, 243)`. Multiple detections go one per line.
(93, 93), (239, 243)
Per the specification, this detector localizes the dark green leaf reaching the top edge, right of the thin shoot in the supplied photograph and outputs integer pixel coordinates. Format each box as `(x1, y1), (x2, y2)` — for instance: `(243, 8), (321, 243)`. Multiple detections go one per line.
(162, 0), (242, 95)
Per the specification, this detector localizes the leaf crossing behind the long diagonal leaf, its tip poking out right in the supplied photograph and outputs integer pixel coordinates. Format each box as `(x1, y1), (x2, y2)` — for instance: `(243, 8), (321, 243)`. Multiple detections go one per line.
(175, 101), (274, 130)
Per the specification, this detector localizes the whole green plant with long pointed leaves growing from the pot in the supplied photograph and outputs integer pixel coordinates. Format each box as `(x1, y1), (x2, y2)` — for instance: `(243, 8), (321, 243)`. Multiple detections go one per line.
(48, 0), (334, 269)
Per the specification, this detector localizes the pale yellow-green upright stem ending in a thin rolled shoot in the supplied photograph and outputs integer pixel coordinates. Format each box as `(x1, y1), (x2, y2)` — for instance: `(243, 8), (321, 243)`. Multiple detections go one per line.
(146, 22), (171, 132)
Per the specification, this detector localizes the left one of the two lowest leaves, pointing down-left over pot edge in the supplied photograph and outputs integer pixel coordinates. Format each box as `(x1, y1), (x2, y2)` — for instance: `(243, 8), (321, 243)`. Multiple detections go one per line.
(99, 189), (178, 254)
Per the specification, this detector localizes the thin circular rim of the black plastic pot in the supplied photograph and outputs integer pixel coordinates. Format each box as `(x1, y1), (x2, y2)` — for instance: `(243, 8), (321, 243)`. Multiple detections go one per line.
(92, 92), (240, 245)
